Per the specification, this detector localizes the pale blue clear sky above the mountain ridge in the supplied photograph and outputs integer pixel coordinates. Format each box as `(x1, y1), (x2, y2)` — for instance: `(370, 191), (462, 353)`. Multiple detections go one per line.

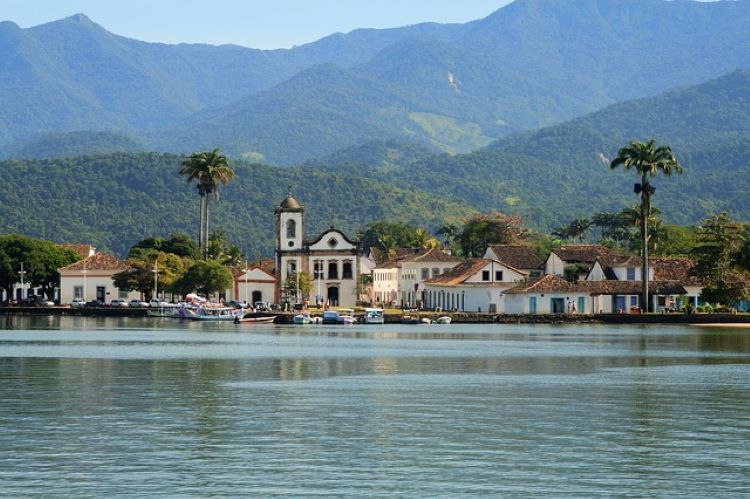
(0, 0), (511, 49)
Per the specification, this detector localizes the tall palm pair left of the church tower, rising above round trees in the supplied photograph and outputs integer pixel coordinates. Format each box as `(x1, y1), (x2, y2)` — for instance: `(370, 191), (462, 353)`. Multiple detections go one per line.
(180, 148), (234, 256)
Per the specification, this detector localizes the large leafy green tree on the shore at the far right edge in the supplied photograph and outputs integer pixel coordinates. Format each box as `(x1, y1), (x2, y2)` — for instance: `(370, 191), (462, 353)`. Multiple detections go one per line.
(691, 213), (750, 304)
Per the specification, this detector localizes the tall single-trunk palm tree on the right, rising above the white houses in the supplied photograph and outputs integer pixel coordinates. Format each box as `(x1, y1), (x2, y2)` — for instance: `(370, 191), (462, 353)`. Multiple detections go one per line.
(609, 139), (682, 312)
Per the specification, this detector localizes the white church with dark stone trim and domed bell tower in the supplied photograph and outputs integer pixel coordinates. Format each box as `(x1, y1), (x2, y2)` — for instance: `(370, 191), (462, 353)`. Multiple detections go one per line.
(274, 193), (361, 307)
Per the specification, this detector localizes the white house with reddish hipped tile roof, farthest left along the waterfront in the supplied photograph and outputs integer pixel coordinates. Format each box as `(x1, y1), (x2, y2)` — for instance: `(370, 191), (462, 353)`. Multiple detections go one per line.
(59, 253), (140, 305)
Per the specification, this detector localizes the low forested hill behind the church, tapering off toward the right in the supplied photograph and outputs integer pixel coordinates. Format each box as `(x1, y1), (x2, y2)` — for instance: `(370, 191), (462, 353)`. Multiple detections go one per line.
(0, 153), (471, 258)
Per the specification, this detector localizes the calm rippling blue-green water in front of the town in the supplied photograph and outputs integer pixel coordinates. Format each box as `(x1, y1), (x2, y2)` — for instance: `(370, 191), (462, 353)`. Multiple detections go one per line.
(0, 317), (750, 497)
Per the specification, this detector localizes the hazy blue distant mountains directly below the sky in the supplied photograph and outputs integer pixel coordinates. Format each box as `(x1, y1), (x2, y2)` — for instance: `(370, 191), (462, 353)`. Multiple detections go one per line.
(0, 0), (750, 164)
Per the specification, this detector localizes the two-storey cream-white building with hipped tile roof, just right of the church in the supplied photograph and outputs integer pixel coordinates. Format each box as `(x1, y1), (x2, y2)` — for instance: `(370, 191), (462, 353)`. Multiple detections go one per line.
(372, 249), (461, 308)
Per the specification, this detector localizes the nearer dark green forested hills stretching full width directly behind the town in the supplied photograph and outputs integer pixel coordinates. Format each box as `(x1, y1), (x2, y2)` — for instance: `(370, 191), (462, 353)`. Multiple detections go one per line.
(0, 71), (750, 257)
